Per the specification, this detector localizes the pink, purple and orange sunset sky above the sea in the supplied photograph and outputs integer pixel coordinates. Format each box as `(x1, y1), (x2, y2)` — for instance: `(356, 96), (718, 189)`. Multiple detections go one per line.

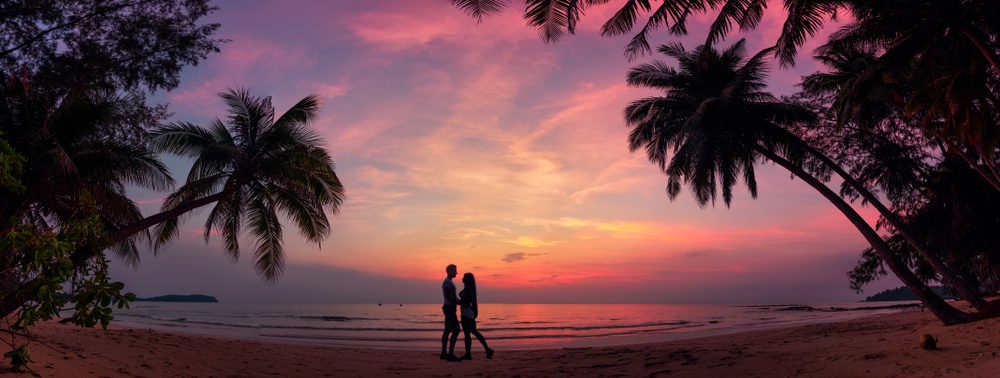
(113, 0), (895, 303)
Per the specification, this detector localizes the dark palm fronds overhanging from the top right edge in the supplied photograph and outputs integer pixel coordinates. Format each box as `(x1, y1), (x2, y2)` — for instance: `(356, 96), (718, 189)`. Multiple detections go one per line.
(488, 0), (1000, 190)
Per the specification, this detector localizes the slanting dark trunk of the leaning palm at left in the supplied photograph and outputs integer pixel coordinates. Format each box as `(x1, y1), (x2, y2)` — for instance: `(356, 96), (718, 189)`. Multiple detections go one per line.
(0, 192), (225, 317)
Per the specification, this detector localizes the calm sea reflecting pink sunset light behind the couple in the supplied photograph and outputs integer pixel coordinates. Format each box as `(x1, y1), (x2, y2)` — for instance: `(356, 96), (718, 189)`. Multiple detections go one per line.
(109, 302), (912, 349)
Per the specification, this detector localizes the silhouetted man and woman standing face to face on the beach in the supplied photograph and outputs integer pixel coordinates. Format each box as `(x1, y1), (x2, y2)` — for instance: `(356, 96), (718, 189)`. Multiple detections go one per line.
(441, 264), (493, 361)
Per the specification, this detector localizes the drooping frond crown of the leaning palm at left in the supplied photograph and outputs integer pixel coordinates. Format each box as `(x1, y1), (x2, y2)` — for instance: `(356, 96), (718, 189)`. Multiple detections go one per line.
(153, 89), (344, 282)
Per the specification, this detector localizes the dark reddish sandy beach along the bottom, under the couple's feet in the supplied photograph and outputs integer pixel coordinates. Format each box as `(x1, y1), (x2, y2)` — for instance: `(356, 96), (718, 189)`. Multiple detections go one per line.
(3, 309), (1000, 377)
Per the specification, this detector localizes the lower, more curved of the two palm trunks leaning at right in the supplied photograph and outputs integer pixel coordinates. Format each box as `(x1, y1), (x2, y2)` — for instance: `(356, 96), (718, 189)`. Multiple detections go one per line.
(755, 146), (974, 325)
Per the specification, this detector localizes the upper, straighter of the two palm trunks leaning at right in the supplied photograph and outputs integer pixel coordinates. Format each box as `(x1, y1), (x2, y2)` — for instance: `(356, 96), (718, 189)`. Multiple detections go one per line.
(789, 133), (986, 310)
